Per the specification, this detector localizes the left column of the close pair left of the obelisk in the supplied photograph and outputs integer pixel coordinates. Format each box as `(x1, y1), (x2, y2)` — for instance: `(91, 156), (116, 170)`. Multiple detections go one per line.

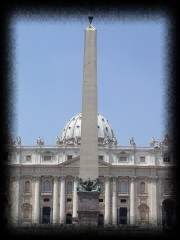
(53, 176), (58, 223)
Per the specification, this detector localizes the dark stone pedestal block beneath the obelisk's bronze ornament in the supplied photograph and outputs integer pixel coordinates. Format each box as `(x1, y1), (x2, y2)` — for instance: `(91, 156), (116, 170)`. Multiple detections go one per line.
(77, 192), (99, 227)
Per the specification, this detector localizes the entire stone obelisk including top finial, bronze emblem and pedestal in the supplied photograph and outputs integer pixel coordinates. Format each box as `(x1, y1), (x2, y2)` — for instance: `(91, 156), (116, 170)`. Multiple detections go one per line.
(77, 15), (100, 226)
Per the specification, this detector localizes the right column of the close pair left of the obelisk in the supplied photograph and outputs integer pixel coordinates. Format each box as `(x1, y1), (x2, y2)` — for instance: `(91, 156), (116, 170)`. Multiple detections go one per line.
(59, 176), (66, 224)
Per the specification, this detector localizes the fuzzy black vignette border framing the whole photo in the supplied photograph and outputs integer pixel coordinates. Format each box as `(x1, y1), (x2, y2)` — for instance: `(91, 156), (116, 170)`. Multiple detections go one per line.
(0, 0), (180, 239)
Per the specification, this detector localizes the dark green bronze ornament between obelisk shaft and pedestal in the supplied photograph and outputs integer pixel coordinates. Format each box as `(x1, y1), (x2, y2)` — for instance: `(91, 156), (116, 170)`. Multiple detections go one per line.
(77, 178), (101, 192)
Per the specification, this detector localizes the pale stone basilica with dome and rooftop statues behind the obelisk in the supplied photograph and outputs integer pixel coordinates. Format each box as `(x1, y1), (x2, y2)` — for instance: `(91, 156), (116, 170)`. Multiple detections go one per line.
(7, 113), (176, 227)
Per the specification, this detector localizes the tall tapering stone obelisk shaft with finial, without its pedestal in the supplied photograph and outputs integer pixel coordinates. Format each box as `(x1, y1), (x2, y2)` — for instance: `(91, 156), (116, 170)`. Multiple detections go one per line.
(79, 14), (98, 180)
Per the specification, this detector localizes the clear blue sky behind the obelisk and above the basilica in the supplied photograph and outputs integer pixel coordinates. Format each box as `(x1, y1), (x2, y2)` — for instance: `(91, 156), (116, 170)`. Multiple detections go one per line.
(13, 16), (167, 146)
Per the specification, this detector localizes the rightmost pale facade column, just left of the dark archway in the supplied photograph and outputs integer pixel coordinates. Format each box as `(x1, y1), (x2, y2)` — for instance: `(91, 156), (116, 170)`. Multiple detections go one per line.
(151, 177), (157, 225)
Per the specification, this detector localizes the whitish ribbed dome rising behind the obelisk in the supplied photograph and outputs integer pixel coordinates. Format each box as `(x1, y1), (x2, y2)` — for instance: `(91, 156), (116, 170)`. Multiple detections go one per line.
(60, 113), (117, 146)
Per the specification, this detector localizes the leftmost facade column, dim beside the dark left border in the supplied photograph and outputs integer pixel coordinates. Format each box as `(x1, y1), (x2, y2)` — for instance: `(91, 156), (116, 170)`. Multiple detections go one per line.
(11, 175), (20, 224)
